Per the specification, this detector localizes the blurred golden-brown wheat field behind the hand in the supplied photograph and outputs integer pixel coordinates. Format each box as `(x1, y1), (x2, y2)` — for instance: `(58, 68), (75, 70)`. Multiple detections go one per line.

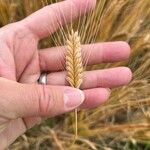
(0, 0), (150, 150)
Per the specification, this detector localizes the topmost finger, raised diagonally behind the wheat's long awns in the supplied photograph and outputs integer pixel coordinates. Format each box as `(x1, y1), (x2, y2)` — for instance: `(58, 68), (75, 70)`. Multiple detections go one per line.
(22, 0), (96, 39)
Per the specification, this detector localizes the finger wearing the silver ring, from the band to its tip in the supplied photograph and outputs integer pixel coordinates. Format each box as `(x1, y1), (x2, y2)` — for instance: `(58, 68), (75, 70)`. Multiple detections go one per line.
(47, 67), (132, 89)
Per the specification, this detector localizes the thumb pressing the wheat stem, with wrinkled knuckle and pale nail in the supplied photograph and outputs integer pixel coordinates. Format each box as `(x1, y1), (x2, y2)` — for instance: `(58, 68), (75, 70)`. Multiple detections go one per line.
(0, 78), (84, 119)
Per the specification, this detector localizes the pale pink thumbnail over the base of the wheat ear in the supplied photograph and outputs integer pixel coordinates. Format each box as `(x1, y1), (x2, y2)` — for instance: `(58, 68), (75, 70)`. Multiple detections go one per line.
(64, 89), (85, 110)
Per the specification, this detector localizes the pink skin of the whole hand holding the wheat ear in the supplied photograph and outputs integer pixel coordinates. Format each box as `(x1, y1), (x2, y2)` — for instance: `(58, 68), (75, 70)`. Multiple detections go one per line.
(0, 0), (132, 149)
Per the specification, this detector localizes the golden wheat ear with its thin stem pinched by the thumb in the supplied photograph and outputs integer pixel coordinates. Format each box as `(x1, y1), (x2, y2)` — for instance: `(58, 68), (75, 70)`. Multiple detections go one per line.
(66, 30), (83, 140)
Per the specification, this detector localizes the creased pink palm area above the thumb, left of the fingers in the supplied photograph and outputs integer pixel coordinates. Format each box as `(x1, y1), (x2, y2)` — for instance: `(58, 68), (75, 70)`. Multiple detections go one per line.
(0, 23), (40, 83)
